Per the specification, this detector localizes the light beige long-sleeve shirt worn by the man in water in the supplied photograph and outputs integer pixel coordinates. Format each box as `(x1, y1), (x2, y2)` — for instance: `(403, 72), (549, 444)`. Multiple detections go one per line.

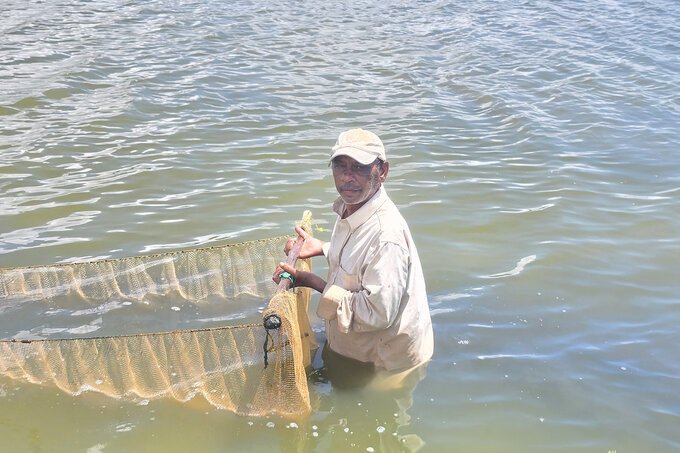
(317, 187), (433, 371)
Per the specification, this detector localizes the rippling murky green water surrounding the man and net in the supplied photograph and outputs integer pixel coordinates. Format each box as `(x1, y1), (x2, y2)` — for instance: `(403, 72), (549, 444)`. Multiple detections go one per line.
(0, 0), (680, 452)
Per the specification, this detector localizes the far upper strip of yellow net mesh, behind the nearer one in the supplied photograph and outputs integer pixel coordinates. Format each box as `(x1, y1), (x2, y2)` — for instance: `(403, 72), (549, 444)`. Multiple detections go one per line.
(0, 233), (286, 305)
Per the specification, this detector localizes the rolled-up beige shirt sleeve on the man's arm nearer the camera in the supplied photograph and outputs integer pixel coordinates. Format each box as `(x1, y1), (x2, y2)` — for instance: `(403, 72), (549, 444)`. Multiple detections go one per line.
(317, 242), (409, 333)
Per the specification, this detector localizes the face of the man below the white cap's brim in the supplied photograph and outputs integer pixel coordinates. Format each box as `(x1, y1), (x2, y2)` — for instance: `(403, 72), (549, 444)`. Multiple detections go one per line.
(331, 156), (387, 208)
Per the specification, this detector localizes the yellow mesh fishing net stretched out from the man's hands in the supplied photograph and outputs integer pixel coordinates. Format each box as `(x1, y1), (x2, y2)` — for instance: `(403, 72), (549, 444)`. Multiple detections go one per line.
(0, 213), (316, 417)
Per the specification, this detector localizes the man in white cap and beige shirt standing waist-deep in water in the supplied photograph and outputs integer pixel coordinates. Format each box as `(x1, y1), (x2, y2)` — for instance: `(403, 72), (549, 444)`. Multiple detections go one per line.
(273, 129), (433, 383)
